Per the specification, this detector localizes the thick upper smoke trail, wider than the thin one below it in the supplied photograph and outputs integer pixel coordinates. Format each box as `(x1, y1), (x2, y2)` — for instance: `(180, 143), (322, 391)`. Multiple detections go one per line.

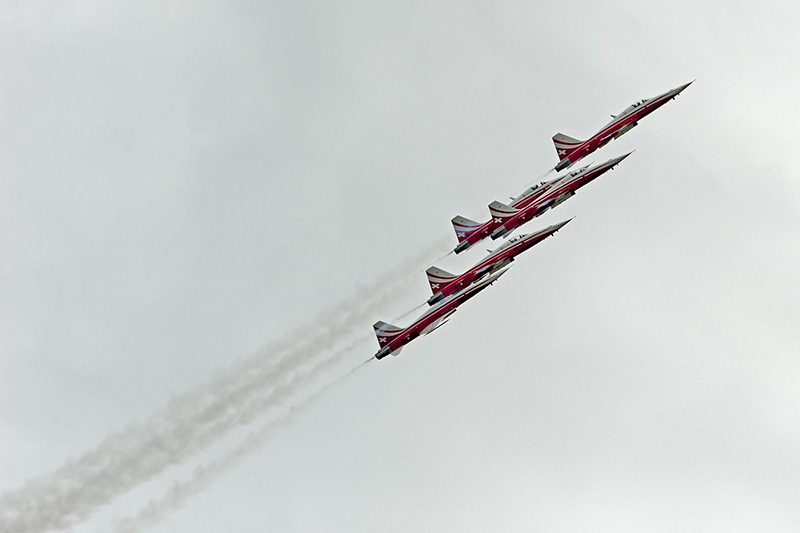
(0, 238), (443, 533)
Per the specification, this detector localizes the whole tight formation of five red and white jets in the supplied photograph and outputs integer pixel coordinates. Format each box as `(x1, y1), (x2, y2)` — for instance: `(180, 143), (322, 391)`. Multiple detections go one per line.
(373, 81), (693, 359)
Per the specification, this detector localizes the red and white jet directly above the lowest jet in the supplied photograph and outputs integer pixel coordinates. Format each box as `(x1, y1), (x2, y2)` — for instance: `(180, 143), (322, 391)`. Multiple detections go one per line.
(425, 219), (572, 305)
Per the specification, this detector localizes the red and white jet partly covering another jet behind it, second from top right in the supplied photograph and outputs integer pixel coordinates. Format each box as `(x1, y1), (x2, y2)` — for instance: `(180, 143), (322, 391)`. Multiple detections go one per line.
(489, 152), (633, 240)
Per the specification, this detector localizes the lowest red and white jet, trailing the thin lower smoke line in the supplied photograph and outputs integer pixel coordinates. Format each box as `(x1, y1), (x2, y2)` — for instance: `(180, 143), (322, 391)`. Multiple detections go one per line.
(372, 267), (510, 359)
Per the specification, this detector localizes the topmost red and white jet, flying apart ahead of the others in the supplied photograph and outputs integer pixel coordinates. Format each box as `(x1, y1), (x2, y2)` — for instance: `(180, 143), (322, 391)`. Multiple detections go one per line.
(553, 80), (694, 171)
